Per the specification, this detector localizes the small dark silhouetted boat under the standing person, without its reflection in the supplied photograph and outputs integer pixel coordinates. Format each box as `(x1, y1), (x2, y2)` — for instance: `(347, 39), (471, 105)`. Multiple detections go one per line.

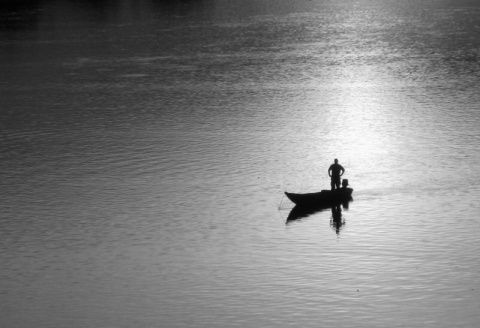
(285, 187), (353, 207)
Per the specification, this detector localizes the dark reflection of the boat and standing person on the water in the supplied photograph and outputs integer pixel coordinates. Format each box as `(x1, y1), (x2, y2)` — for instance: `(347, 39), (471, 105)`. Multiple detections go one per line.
(286, 197), (353, 234)
